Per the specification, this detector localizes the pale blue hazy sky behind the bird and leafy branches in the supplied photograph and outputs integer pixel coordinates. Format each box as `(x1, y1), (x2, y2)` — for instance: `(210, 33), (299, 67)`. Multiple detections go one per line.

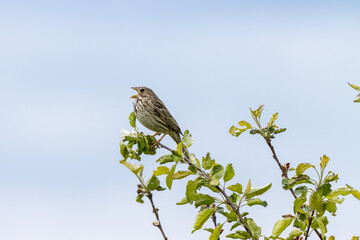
(0, 0), (360, 240)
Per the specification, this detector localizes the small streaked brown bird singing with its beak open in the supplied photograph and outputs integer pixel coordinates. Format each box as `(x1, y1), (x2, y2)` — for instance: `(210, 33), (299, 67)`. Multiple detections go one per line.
(130, 87), (183, 146)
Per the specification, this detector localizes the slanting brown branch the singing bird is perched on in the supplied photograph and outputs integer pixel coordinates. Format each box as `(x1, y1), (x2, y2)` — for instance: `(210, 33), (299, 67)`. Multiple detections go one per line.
(159, 143), (257, 239)
